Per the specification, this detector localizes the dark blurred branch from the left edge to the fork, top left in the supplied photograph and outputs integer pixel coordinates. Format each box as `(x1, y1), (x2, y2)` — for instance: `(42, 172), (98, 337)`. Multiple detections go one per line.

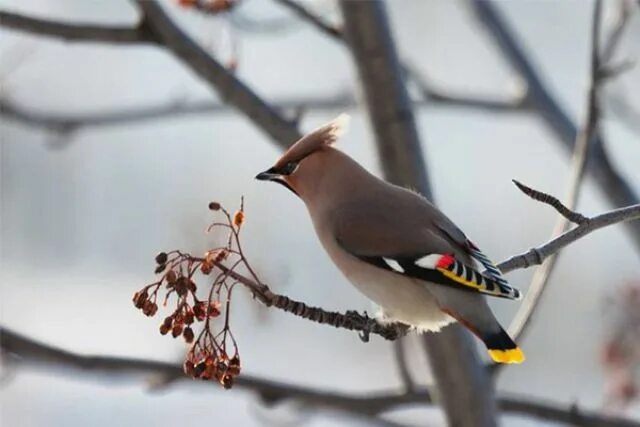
(0, 11), (155, 44)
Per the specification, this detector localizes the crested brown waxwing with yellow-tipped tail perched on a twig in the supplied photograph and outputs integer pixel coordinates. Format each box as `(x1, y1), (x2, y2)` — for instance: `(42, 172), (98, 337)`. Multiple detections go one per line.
(255, 113), (525, 363)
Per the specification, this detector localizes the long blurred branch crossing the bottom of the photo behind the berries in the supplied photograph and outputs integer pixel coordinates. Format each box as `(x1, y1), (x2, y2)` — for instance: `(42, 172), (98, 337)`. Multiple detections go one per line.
(0, 327), (640, 427)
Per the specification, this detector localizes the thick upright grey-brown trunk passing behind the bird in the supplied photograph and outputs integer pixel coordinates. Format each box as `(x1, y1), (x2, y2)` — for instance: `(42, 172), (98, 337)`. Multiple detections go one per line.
(341, 0), (497, 427)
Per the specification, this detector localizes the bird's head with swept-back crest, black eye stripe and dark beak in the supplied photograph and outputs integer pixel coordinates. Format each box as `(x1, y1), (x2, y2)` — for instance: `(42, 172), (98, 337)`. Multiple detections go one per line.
(256, 113), (349, 198)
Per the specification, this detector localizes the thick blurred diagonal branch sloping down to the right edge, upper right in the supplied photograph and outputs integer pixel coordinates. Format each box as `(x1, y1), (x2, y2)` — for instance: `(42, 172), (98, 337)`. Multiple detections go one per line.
(472, 0), (640, 249)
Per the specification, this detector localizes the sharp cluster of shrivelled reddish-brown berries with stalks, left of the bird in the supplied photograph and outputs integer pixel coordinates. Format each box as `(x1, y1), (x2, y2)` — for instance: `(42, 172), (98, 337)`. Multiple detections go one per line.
(133, 202), (252, 388)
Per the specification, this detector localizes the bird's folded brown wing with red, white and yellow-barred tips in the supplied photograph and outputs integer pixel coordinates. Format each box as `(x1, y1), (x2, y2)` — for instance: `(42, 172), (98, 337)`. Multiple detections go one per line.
(334, 196), (520, 299)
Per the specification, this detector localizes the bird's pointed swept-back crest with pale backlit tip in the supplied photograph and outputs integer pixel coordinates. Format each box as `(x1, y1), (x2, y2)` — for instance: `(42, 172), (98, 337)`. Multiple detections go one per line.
(274, 113), (350, 168)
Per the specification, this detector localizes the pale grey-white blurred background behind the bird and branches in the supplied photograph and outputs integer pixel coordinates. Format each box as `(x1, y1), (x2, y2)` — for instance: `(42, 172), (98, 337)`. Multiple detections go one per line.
(0, 0), (640, 426)
